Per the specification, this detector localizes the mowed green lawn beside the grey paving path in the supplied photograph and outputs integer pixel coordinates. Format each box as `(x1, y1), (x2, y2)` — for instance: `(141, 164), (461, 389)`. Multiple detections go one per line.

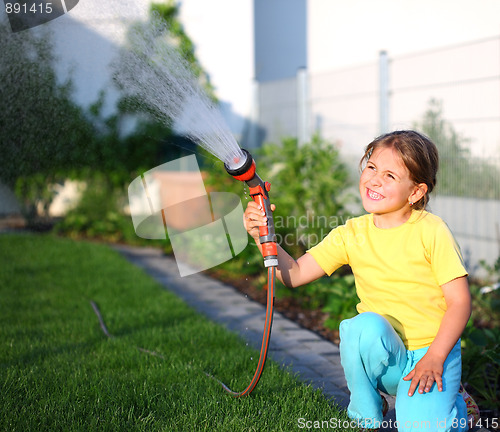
(0, 234), (352, 432)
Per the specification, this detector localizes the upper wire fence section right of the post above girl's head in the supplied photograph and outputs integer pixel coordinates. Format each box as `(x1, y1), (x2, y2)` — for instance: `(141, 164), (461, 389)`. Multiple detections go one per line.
(390, 37), (500, 200)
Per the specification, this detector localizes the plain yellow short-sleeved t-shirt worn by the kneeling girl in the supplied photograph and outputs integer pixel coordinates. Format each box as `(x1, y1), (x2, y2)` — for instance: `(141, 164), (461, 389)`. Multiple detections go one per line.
(308, 211), (467, 350)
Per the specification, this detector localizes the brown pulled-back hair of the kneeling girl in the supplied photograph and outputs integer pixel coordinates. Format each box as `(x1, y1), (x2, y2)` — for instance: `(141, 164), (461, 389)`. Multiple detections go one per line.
(359, 130), (439, 210)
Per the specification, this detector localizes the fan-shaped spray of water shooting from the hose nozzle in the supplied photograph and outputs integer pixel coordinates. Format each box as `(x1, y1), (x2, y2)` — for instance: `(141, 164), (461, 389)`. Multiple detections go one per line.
(113, 15), (245, 169)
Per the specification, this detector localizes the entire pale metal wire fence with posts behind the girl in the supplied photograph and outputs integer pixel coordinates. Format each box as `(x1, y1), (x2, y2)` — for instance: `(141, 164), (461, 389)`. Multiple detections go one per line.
(257, 36), (500, 276)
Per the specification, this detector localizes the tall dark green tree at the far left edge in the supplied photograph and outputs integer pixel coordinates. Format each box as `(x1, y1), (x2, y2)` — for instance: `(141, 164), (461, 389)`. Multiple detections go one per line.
(0, 23), (93, 186)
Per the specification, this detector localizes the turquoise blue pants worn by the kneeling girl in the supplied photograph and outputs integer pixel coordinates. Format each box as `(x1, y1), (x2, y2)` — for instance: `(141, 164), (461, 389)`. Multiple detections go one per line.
(340, 312), (468, 432)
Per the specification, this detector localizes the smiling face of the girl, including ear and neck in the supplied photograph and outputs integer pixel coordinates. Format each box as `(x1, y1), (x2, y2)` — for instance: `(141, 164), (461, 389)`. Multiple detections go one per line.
(359, 147), (426, 228)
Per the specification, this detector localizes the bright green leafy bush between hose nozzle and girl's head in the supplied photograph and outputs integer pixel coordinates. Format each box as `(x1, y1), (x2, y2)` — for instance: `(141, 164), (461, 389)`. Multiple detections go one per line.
(257, 136), (357, 257)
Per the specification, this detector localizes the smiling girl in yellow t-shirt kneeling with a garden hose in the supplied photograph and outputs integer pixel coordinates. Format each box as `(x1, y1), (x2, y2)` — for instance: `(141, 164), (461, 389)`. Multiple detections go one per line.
(244, 131), (478, 431)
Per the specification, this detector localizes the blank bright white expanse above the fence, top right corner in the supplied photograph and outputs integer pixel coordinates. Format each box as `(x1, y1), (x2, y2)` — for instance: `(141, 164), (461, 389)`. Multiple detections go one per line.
(308, 0), (500, 72)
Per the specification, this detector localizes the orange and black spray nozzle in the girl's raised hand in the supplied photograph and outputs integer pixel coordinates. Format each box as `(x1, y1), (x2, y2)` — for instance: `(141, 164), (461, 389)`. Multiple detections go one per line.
(224, 149), (278, 267)
